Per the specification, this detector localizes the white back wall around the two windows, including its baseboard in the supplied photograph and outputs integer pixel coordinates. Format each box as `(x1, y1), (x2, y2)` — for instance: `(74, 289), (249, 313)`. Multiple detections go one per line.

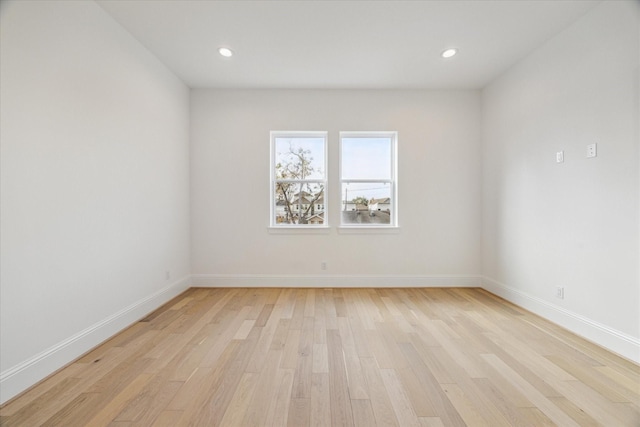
(191, 90), (480, 286)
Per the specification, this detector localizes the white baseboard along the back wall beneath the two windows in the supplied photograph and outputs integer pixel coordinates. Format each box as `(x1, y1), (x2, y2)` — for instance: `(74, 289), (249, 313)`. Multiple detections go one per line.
(191, 274), (481, 288)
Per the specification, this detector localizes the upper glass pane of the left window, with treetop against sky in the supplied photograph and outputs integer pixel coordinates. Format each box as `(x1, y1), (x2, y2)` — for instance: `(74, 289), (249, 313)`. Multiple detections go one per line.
(275, 137), (325, 179)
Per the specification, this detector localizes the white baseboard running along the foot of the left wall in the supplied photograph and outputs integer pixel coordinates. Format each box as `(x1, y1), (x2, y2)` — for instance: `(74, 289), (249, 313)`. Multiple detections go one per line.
(0, 276), (191, 404)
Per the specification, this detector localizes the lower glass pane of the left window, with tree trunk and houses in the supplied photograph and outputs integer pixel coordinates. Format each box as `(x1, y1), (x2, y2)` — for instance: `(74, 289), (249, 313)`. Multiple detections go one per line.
(274, 183), (325, 225)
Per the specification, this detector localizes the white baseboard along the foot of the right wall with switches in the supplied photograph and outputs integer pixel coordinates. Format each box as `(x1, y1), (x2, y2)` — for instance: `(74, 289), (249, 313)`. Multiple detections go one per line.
(481, 277), (640, 363)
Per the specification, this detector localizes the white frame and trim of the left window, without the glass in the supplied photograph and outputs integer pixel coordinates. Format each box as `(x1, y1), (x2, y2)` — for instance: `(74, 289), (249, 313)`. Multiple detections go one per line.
(269, 131), (329, 229)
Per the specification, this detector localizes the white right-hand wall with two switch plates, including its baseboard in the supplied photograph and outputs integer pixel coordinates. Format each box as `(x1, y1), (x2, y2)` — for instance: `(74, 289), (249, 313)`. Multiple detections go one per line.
(482, 2), (640, 361)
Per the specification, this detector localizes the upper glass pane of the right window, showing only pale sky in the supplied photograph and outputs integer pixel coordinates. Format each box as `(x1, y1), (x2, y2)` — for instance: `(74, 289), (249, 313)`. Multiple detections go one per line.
(341, 137), (391, 179)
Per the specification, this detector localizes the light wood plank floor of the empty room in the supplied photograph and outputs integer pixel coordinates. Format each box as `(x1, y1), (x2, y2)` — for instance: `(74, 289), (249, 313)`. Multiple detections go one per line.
(0, 288), (640, 427)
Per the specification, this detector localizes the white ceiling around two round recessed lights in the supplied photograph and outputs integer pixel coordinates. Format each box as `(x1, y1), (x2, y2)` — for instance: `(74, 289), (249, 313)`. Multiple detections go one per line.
(97, 0), (599, 89)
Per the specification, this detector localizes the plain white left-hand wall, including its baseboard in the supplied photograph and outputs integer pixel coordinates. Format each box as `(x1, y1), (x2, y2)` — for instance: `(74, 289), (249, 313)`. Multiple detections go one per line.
(0, 1), (190, 402)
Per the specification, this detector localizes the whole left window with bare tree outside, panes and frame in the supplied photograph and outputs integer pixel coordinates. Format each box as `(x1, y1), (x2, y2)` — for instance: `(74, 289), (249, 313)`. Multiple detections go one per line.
(271, 132), (327, 226)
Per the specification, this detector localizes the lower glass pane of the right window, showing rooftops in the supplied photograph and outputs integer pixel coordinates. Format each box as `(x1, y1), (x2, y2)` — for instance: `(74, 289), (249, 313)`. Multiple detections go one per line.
(341, 182), (392, 225)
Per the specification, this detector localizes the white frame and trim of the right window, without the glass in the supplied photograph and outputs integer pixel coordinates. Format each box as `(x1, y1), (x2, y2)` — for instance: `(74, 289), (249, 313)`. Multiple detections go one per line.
(338, 131), (399, 229)
